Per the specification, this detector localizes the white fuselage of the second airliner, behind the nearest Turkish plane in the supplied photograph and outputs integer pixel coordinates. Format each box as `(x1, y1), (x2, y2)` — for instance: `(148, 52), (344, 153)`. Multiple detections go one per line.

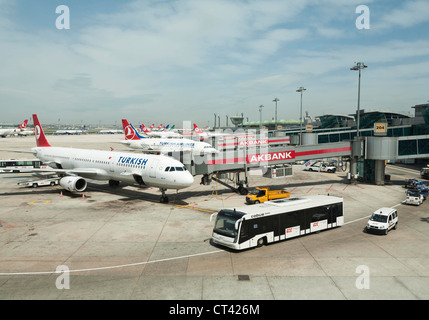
(121, 138), (219, 154)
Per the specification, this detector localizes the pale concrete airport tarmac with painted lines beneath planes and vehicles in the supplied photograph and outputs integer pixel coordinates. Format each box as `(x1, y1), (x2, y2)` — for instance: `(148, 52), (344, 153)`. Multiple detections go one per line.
(0, 135), (429, 301)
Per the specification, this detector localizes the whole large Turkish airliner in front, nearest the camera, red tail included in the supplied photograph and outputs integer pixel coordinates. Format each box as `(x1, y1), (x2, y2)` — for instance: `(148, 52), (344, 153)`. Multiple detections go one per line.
(5, 114), (194, 203)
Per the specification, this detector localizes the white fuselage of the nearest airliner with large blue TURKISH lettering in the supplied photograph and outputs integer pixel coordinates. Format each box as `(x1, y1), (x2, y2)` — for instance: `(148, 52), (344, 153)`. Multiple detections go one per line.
(32, 147), (194, 189)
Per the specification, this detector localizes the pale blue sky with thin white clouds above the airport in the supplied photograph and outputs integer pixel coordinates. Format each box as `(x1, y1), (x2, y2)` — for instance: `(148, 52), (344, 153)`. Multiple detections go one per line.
(0, 0), (429, 126)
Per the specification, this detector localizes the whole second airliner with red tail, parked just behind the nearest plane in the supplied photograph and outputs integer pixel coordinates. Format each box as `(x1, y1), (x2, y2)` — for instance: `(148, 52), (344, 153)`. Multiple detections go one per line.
(120, 119), (219, 154)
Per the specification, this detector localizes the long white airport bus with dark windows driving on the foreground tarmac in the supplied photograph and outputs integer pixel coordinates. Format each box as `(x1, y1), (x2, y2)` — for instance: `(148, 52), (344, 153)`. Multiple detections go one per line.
(210, 195), (344, 250)
